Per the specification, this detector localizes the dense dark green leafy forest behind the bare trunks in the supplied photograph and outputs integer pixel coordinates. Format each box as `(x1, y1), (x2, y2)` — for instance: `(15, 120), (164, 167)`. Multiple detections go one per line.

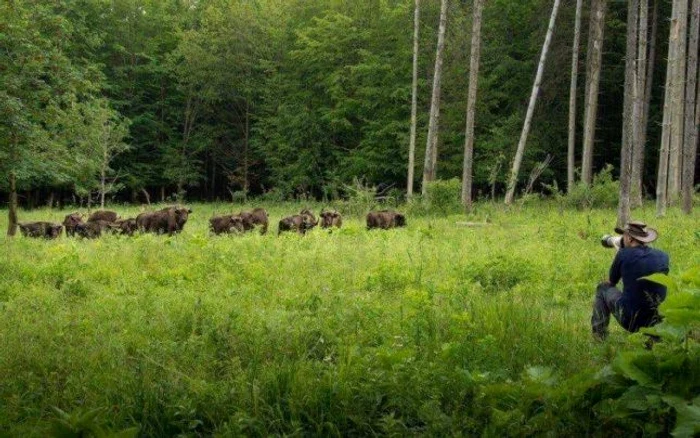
(0, 0), (697, 207)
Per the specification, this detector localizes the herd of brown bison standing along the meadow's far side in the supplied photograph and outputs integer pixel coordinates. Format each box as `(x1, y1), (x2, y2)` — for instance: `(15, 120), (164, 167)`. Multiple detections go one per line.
(19, 207), (406, 239)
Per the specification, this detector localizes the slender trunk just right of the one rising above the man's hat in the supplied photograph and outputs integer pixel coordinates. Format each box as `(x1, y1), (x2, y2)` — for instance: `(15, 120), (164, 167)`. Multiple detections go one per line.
(630, 0), (659, 208)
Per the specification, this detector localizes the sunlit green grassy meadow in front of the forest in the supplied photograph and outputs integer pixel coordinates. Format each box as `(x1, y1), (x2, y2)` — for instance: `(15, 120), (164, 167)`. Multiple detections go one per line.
(0, 202), (700, 436)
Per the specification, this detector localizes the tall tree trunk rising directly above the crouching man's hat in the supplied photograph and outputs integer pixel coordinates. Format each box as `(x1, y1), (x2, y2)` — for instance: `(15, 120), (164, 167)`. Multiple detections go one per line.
(617, 0), (639, 227)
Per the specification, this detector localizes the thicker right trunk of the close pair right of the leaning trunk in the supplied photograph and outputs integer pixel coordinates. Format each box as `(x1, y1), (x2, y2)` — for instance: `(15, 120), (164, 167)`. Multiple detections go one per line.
(581, 0), (607, 185)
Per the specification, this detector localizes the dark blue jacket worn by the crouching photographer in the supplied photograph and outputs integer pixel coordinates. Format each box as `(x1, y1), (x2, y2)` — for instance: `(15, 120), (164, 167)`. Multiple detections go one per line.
(610, 246), (669, 332)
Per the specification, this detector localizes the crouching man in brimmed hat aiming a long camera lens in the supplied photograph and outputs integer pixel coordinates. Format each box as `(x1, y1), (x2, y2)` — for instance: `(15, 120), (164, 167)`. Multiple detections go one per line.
(591, 221), (669, 340)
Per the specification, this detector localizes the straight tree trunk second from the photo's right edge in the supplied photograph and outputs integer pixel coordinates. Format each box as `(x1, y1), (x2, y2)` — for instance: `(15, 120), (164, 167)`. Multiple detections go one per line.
(667, 0), (688, 204)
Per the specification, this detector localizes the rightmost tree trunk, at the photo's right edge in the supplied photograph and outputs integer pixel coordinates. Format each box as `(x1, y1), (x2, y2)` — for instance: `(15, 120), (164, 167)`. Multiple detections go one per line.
(681, 0), (700, 214)
